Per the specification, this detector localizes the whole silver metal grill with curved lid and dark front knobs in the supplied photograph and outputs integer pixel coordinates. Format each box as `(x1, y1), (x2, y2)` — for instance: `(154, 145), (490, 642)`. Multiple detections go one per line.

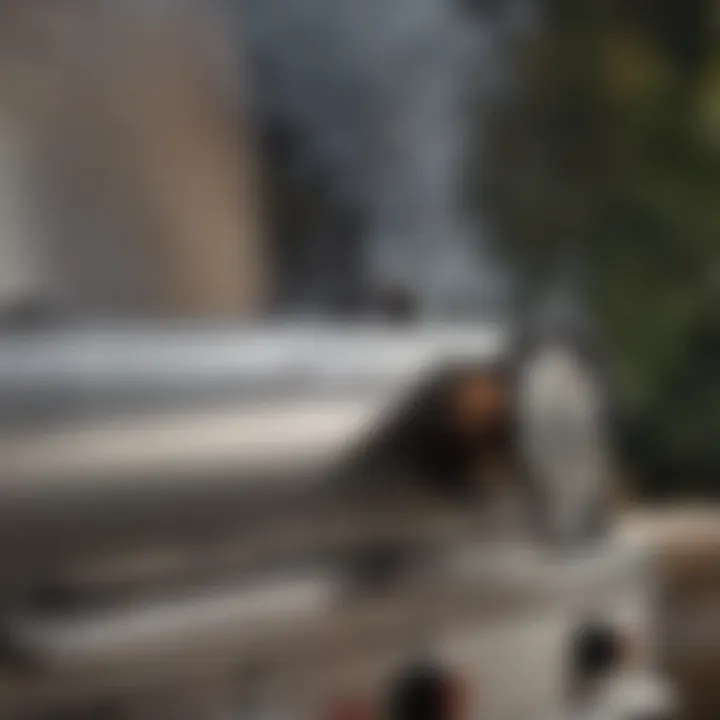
(0, 324), (670, 720)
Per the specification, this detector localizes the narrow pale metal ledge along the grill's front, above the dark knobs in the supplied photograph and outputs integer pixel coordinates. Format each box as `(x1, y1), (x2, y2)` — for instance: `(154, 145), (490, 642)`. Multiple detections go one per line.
(7, 544), (638, 670)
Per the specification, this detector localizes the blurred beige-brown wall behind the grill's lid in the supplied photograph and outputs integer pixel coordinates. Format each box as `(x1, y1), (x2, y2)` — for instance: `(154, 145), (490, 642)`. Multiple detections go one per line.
(0, 0), (264, 317)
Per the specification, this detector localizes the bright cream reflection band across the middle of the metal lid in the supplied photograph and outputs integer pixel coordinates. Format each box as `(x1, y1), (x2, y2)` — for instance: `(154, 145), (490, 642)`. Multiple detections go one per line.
(0, 393), (389, 486)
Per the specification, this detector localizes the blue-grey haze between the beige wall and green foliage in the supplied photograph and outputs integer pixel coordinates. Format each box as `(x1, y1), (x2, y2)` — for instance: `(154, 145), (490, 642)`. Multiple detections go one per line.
(236, 0), (527, 315)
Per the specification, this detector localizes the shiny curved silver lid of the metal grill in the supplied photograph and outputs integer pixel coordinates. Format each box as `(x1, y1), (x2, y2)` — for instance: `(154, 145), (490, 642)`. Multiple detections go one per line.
(0, 325), (503, 589)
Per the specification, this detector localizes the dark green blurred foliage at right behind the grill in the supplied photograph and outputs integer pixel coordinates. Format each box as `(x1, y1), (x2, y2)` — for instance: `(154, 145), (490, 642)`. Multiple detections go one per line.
(471, 0), (720, 491)
